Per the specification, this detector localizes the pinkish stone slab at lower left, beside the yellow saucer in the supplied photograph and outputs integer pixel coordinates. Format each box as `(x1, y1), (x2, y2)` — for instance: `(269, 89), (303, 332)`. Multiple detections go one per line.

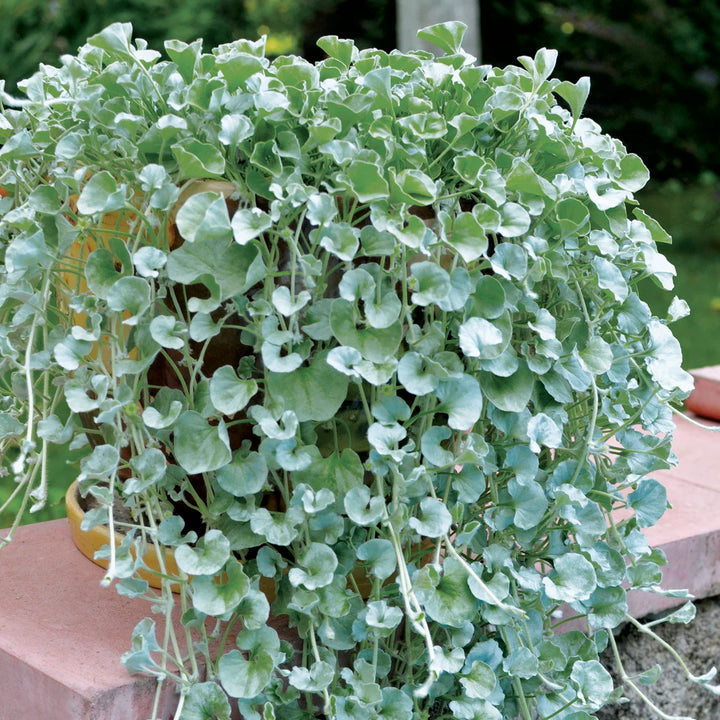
(0, 520), (177, 720)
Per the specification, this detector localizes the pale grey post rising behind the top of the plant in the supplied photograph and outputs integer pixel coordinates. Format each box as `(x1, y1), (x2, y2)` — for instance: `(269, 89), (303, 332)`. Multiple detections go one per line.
(396, 0), (480, 60)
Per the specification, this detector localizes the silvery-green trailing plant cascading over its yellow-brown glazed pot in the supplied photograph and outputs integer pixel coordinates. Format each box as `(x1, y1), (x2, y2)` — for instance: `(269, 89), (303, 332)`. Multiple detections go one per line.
(0, 18), (707, 720)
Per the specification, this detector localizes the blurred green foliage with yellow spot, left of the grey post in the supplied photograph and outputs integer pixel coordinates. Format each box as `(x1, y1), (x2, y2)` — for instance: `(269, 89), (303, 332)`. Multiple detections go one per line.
(0, 0), (395, 92)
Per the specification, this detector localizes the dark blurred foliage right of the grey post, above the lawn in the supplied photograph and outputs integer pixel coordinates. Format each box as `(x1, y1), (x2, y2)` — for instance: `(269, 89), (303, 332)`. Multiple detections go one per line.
(481, 0), (720, 180)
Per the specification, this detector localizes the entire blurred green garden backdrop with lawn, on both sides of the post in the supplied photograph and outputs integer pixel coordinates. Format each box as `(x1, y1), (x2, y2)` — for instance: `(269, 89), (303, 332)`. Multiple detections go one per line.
(0, 0), (720, 527)
